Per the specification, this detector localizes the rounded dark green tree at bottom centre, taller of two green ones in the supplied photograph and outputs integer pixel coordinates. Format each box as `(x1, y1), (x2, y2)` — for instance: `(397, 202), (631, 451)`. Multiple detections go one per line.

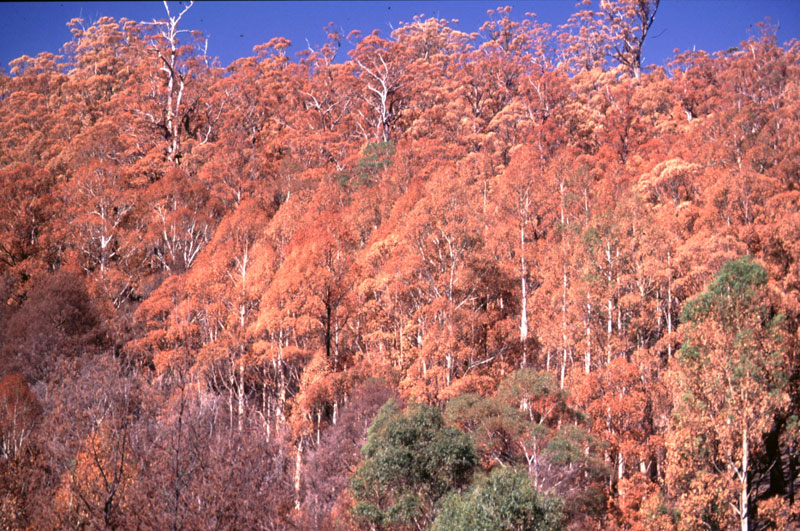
(351, 401), (477, 527)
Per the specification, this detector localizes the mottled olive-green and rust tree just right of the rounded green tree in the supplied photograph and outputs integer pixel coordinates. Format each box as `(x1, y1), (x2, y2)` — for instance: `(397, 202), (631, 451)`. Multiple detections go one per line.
(445, 368), (609, 525)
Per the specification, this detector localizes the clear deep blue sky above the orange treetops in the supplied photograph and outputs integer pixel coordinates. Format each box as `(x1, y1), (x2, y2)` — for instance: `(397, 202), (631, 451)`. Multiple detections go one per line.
(0, 0), (800, 70)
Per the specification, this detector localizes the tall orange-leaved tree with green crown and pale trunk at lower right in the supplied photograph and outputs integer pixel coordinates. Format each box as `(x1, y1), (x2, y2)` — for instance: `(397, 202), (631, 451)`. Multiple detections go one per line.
(667, 257), (787, 531)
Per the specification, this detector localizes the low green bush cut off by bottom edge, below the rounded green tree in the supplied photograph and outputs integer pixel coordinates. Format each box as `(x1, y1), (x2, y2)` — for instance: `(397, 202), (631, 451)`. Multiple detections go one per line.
(432, 468), (564, 531)
